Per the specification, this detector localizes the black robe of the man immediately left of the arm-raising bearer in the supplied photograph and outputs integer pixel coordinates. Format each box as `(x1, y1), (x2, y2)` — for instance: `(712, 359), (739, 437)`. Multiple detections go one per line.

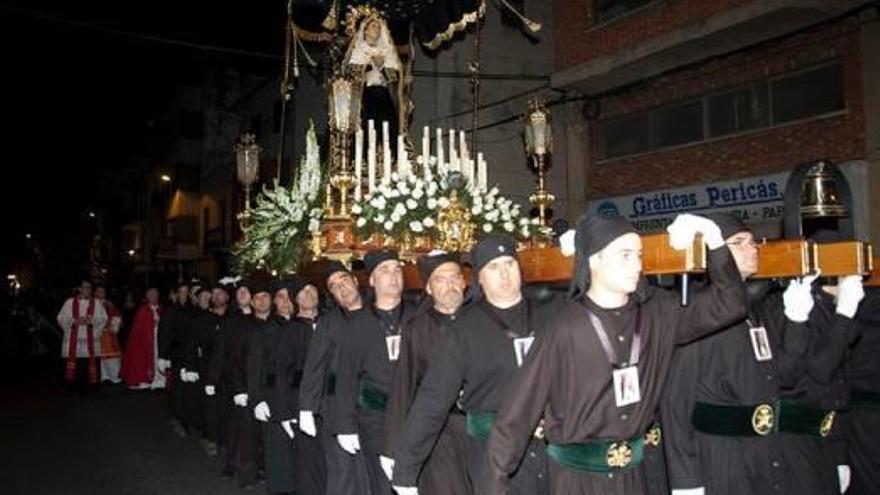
(394, 299), (556, 495)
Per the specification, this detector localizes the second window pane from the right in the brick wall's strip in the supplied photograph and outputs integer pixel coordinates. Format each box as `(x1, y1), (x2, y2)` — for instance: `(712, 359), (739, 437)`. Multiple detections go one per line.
(708, 83), (769, 137)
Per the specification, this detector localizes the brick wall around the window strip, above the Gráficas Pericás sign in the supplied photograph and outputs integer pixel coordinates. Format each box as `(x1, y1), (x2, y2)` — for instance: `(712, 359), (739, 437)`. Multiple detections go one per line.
(584, 17), (865, 199)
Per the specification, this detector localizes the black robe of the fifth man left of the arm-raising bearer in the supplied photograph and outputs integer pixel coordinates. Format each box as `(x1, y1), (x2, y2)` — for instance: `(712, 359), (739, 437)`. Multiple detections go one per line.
(270, 318), (326, 495)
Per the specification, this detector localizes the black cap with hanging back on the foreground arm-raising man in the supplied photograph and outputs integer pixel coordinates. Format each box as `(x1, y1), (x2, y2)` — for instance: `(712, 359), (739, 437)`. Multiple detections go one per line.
(568, 214), (638, 298)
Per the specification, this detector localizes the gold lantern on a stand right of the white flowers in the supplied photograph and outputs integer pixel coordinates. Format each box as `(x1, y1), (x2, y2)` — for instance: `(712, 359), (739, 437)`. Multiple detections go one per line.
(523, 98), (556, 227)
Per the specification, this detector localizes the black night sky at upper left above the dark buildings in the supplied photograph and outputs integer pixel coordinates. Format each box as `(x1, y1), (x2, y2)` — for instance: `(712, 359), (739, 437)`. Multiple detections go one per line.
(0, 0), (285, 260)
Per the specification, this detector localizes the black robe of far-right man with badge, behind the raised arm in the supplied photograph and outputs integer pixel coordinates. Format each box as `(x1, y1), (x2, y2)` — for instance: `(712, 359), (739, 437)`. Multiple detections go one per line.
(661, 284), (836, 495)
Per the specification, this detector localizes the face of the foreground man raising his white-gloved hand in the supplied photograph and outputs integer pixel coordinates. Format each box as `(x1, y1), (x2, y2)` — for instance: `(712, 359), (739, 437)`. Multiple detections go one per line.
(590, 234), (642, 294)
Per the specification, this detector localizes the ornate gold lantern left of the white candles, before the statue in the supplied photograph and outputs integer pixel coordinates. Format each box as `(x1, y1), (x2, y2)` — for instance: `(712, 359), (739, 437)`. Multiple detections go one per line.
(327, 77), (361, 218)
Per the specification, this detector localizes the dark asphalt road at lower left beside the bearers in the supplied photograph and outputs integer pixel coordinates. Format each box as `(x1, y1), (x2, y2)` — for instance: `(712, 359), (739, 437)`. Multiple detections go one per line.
(0, 366), (253, 495)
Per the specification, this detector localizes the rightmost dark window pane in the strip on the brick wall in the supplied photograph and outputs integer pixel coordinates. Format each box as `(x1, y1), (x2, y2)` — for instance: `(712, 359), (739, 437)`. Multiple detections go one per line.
(770, 64), (845, 124)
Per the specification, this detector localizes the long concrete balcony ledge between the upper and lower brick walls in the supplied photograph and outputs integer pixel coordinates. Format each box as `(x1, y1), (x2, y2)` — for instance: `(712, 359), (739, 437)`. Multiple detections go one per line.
(551, 0), (872, 94)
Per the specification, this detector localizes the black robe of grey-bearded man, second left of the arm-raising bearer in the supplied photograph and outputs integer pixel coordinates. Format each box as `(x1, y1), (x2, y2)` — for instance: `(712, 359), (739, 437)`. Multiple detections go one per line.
(384, 298), (471, 495)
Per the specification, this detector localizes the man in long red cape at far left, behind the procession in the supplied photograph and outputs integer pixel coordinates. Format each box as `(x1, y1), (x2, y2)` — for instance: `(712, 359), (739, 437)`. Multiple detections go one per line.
(121, 288), (165, 390)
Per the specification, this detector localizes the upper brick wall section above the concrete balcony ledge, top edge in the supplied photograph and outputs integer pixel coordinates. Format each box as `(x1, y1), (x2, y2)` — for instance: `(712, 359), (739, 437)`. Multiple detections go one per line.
(554, 0), (756, 70)
